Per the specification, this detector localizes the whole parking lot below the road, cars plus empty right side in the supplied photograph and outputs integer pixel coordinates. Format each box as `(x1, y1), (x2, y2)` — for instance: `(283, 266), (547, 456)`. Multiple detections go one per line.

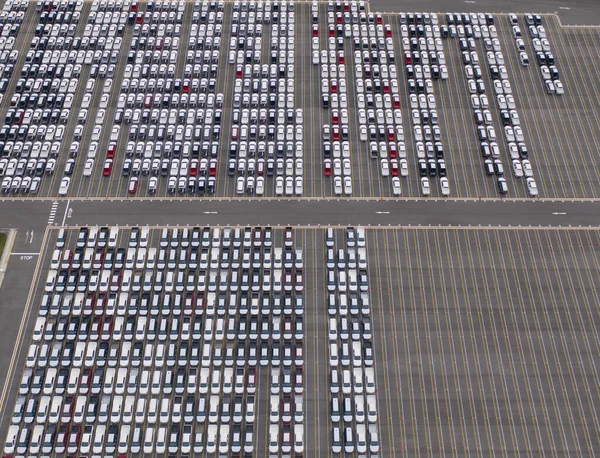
(0, 227), (600, 456)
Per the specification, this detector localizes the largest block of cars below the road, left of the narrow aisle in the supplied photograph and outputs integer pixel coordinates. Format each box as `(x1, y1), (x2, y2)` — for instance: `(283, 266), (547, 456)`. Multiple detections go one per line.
(4, 227), (304, 456)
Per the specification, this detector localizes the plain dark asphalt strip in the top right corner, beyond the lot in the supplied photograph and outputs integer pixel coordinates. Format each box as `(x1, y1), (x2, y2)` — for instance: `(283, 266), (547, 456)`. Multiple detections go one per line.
(369, 0), (600, 25)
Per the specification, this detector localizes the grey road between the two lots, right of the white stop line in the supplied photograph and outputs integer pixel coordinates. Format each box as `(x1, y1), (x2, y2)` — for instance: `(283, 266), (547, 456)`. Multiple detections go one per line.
(59, 199), (600, 226)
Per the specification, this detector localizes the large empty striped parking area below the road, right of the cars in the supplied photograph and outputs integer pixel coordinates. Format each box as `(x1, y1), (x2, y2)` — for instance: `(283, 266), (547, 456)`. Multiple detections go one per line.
(367, 229), (600, 456)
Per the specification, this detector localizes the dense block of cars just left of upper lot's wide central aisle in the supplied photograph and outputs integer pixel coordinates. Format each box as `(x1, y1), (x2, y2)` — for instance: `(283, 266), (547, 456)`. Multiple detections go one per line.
(228, 2), (304, 196)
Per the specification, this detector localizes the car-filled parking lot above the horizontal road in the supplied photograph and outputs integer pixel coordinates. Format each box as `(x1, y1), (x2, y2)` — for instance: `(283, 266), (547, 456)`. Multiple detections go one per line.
(0, 1), (598, 198)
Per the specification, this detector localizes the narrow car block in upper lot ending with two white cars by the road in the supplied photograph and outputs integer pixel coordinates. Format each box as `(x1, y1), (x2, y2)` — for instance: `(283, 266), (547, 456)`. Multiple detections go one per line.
(401, 13), (450, 196)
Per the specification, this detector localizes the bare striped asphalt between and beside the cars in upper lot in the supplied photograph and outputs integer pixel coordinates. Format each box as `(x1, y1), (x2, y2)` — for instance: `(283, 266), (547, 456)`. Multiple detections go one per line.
(0, 1), (600, 198)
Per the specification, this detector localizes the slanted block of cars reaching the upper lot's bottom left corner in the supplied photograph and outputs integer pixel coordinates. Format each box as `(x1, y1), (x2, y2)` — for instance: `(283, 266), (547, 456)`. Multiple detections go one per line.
(0, 2), (82, 194)
